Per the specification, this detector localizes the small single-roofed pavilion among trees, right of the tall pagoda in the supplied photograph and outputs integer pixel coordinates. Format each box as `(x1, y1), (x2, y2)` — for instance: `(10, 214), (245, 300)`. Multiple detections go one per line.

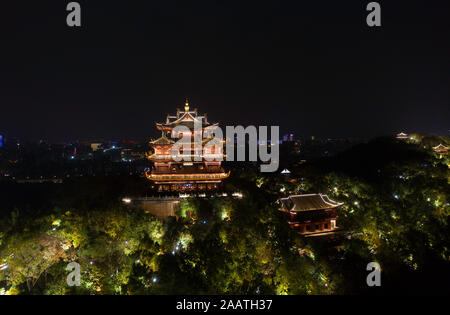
(277, 194), (343, 236)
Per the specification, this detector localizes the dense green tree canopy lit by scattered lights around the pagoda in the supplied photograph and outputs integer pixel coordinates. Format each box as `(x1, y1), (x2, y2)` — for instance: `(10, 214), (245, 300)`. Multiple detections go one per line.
(0, 138), (450, 294)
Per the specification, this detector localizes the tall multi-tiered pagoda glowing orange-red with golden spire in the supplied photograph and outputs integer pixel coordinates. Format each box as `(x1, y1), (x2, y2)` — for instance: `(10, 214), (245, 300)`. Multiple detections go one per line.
(146, 99), (229, 192)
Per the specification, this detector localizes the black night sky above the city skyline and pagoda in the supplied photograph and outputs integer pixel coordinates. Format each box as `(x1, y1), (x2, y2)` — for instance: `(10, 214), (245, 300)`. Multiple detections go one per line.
(0, 0), (450, 140)
